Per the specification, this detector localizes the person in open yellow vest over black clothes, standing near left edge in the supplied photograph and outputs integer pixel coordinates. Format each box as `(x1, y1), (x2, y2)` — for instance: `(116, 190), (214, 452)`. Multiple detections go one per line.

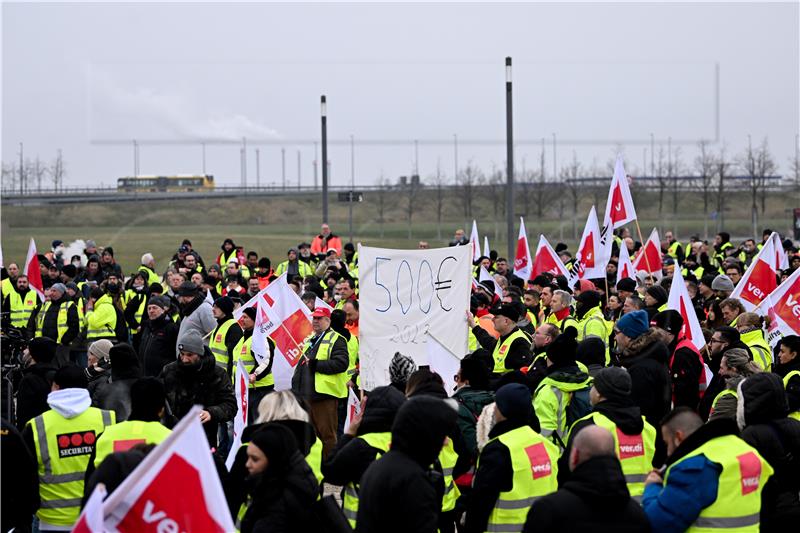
(34, 283), (81, 367)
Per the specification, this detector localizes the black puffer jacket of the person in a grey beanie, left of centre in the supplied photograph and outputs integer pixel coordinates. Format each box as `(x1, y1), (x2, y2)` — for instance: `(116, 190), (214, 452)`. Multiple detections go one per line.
(158, 346), (237, 447)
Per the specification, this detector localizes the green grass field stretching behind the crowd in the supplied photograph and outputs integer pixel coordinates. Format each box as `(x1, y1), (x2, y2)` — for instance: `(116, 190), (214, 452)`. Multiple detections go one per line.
(0, 189), (800, 273)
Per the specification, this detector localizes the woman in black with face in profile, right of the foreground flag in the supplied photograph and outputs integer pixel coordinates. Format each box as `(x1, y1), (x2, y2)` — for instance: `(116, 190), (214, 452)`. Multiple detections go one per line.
(237, 422), (320, 533)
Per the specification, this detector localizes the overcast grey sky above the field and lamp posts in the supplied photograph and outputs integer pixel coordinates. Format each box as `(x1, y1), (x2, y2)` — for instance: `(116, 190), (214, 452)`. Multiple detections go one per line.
(2, 2), (800, 186)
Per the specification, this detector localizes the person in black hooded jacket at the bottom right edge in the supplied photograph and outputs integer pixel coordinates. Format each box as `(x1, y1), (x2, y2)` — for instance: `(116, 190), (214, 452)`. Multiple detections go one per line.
(736, 372), (800, 531)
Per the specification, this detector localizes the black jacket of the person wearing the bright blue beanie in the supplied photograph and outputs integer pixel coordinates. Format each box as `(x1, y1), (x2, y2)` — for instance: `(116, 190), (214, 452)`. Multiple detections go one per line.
(620, 328), (672, 427)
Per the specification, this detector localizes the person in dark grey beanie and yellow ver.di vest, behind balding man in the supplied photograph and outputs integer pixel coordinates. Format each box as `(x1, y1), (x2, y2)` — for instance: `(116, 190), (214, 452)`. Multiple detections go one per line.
(558, 367), (656, 502)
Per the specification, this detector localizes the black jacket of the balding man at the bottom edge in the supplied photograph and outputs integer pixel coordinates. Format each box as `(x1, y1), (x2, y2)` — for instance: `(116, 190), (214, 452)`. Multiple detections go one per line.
(523, 456), (650, 533)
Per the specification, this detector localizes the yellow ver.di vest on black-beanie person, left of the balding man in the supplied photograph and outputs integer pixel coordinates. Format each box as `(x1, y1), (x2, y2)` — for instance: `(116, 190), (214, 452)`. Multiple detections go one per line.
(478, 426), (559, 531)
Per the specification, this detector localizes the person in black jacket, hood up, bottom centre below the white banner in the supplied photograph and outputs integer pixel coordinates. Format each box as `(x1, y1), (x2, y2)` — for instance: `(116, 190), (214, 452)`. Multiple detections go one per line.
(356, 396), (456, 533)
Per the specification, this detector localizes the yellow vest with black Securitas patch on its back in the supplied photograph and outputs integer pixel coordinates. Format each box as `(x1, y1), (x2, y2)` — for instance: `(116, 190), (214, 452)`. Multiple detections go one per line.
(28, 407), (115, 527)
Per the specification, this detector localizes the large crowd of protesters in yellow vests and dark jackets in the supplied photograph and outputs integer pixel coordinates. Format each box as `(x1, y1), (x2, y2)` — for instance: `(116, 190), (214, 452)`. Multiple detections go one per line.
(2, 224), (800, 532)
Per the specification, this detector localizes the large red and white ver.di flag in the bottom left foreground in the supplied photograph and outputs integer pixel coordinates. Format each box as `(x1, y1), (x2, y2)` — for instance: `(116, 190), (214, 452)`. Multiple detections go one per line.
(98, 405), (234, 533)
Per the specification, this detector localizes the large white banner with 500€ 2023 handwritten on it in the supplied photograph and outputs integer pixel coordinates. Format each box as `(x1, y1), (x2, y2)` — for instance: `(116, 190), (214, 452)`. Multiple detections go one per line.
(358, 246), (472, 390)
